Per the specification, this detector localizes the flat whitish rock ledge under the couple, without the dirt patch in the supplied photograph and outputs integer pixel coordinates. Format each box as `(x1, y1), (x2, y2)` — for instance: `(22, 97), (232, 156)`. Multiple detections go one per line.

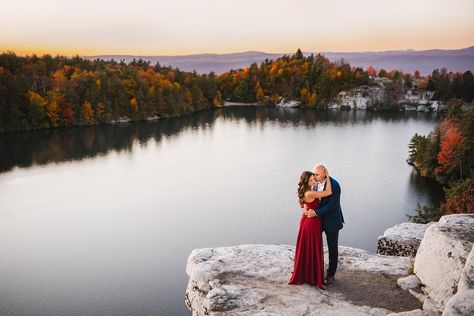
(185, 245), (412, 316)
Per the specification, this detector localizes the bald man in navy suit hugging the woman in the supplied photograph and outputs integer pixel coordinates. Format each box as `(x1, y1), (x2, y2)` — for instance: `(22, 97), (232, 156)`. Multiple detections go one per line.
(305, 165), (344, 285)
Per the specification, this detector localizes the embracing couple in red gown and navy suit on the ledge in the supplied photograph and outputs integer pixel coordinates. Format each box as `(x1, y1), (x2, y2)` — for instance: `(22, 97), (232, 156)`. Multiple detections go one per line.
(289, 165), (344, 289)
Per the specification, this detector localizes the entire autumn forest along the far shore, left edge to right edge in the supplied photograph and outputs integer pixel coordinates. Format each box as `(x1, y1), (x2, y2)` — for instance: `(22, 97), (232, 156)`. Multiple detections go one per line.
(0, 49), (474, 132)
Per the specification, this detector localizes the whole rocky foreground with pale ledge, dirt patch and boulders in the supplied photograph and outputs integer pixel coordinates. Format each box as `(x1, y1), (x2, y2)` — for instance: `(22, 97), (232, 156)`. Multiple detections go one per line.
(185, 215), (474, 315)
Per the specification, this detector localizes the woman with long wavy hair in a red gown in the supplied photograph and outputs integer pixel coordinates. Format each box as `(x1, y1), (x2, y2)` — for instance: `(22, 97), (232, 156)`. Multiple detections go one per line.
(289, 171), (332, 289)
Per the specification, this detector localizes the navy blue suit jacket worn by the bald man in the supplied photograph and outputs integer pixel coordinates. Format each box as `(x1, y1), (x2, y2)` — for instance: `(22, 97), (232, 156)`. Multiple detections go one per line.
(316, 177), (344, 232)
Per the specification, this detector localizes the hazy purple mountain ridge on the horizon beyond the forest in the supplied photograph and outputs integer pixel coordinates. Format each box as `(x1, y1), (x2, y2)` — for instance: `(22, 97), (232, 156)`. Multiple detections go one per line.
(83, 46), (474, 75)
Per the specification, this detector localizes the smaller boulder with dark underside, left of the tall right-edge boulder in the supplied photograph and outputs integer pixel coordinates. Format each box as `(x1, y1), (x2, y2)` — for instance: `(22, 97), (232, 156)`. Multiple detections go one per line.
(377, 223), (427, 257)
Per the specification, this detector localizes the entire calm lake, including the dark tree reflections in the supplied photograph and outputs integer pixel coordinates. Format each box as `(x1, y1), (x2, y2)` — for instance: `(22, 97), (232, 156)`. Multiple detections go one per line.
(0, 108), (441, 315)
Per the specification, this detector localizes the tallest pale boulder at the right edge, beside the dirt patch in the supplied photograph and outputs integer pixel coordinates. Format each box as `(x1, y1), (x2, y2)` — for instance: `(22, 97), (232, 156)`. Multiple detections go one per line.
(414, 214), (474, 311)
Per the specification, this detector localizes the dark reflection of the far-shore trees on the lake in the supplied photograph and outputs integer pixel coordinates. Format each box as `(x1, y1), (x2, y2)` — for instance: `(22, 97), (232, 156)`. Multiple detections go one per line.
(0, 107), (437, 172)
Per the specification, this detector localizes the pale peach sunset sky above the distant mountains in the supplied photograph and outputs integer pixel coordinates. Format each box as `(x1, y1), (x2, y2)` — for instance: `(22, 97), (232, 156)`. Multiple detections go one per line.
(0, 0), (474, 56)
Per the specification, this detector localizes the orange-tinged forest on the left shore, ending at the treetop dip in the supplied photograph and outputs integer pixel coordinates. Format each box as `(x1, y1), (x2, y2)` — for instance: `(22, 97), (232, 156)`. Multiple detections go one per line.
(0, 52), (222, 131)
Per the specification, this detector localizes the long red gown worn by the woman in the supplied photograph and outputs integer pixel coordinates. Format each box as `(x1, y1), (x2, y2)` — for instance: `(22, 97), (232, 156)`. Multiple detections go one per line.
(289, 199), (324, 288)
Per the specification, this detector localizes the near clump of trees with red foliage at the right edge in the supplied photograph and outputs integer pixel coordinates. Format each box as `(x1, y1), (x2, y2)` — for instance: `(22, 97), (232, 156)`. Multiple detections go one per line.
(409, 104), (474, 221)
